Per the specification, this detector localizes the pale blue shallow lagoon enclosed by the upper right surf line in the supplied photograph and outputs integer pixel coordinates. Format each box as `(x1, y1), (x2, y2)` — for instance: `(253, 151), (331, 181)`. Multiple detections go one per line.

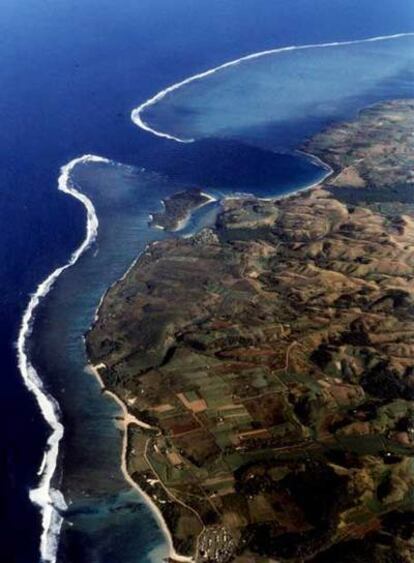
(141, 36), (414, 149)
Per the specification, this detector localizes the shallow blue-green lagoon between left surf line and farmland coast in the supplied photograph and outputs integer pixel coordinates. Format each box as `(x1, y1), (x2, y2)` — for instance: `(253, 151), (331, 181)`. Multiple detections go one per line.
(32, 163), (171, 563)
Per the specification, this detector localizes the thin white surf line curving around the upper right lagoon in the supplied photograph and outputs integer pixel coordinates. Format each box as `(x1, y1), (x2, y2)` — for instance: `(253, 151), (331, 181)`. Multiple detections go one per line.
(131, 31), (414, 143)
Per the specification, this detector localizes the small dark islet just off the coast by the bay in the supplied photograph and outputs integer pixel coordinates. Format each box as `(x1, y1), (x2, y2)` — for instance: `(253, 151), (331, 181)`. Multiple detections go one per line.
(150, 188), (214, 232)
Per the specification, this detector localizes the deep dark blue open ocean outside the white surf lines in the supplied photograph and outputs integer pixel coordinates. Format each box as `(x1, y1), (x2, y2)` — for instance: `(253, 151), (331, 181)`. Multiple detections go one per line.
(0, 0), (414, 563)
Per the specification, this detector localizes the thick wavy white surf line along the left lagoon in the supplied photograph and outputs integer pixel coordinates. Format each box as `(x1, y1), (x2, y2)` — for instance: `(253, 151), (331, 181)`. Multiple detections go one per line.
(17, 155), (110, 563)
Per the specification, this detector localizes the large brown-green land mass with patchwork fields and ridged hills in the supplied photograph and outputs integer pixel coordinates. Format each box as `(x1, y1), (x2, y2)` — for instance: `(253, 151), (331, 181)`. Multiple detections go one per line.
(86, 100), (414, 563)
